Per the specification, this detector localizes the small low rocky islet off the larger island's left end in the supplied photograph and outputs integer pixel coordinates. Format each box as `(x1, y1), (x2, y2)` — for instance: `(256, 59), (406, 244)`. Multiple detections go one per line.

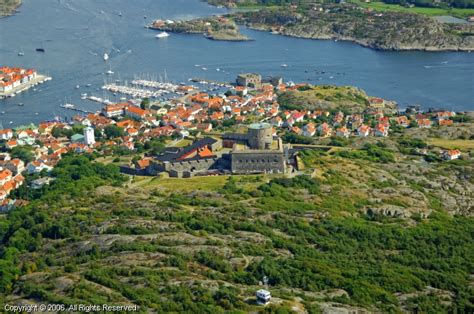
(150, 16), (250, 41)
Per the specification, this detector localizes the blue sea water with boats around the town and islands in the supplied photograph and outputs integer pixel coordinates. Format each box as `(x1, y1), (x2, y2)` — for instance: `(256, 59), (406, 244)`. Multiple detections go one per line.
(0, 0), (474, 127)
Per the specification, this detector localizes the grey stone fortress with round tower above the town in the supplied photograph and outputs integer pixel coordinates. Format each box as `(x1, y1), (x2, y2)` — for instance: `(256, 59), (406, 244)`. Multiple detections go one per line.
(127, 123), (289, 178)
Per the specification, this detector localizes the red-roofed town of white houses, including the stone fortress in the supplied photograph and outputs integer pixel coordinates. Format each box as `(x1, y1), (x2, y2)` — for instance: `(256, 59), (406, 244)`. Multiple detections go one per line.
(0, 71), (462, 211)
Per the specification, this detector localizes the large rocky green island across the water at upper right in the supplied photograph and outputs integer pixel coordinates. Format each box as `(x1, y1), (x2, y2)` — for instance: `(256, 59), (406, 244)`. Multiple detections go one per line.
(196, 1), (474, 51)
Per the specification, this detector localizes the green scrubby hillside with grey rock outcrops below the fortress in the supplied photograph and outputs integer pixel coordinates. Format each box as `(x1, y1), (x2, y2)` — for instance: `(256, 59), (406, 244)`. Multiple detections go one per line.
(0, 146), (474, 313)
